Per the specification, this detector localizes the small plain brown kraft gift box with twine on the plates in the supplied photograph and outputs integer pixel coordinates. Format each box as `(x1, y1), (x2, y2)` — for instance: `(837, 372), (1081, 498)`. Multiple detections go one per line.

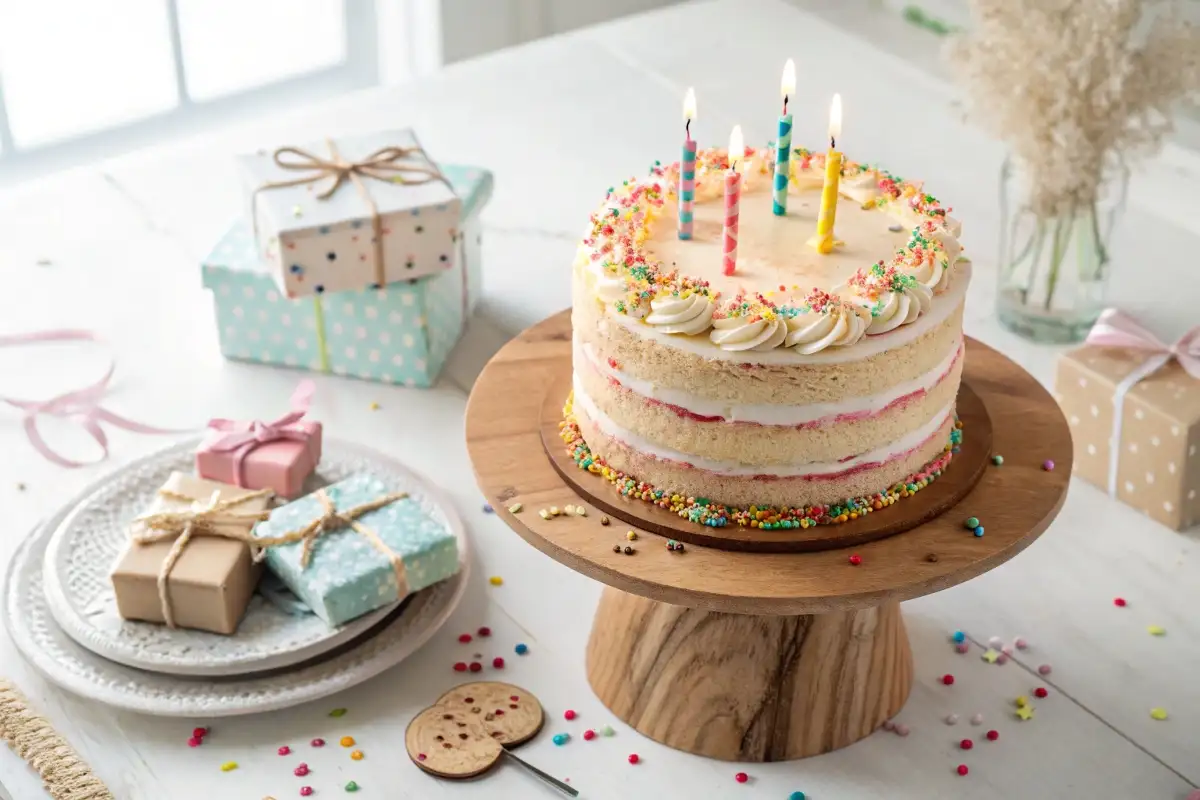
(112, 473), (271, 633)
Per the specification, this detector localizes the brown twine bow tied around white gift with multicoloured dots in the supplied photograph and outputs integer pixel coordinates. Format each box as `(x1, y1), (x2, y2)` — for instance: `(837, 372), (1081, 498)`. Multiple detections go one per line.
(254, 139), (450, 288)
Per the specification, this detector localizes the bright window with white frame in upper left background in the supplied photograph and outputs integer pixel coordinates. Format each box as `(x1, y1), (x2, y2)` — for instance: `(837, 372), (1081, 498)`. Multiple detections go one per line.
(0, 0), (378, 179)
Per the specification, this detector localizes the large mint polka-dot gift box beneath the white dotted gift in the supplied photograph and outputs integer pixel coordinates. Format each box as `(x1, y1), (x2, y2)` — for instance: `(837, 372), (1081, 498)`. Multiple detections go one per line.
(203, 166), (492, 386)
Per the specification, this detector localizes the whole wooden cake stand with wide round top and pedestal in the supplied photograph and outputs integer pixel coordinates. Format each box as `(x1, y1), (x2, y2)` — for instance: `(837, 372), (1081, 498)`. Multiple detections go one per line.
(467, 312), (1072, 762)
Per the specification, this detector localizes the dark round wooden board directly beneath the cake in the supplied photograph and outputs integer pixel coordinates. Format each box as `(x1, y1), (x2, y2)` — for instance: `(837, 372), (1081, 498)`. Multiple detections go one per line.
(541, 374), (991, 553)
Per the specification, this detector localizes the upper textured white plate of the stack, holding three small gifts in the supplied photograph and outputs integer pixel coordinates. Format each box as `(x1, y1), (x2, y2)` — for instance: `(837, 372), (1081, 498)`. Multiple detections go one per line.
(44, 440), (451, 676)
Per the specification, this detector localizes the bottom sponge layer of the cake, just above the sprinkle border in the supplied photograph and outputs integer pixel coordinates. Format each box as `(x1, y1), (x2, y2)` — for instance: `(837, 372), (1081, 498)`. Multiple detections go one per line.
(574, 391), (954, 507)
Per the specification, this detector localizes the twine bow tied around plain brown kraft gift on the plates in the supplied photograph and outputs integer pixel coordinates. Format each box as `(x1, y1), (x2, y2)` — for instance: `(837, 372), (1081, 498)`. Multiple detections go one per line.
(133, 489), (272, 627)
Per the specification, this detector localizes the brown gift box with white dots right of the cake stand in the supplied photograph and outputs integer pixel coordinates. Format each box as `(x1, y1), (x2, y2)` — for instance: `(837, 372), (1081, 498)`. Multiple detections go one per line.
(1055, 317), (1200, 530)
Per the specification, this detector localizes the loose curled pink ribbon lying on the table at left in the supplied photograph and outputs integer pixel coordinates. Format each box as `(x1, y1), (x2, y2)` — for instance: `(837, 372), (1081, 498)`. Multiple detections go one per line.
(0, 329), (182, 468)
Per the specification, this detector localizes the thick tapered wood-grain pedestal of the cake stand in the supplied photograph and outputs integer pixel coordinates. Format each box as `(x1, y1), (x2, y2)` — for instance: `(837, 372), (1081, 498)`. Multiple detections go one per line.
(587, 588), (912, 762)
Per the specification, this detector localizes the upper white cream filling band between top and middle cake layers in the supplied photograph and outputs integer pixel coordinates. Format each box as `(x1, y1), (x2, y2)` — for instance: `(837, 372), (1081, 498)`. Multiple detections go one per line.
(574, 337), (962, 426)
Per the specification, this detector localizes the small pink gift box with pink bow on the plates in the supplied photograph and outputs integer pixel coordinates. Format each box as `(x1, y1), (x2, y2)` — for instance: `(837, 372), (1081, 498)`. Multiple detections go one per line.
(196, 380), (322, 498)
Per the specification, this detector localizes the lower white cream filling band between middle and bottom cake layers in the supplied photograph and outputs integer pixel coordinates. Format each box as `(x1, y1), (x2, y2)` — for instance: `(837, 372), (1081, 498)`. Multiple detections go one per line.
(572, 373), (954, 477)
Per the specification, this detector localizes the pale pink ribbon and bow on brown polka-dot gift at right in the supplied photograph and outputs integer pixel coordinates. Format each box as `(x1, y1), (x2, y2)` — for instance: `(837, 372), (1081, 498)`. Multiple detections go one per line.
(1086, 308), (1200, 497)
